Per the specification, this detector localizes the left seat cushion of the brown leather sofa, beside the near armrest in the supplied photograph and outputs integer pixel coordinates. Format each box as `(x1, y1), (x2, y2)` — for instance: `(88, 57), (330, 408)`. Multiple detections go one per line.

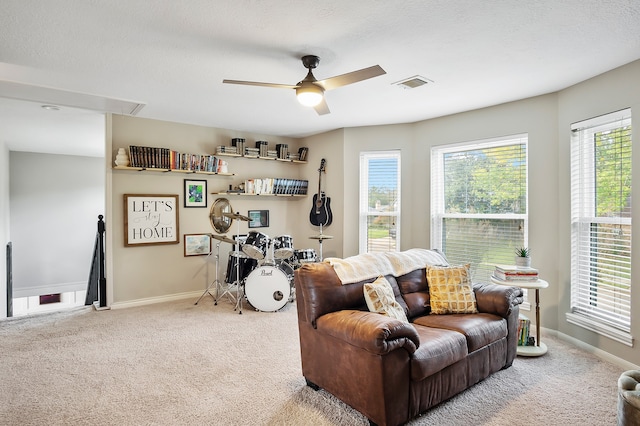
(411, 323), (468, 381)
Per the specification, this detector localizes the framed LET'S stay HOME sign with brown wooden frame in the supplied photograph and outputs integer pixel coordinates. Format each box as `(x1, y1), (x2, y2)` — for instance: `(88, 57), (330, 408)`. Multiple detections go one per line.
(124, 194), (180, 246)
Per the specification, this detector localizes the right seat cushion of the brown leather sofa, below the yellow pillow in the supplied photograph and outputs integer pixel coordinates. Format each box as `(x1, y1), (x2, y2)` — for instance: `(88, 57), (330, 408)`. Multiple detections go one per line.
(413, 313), (507, 353)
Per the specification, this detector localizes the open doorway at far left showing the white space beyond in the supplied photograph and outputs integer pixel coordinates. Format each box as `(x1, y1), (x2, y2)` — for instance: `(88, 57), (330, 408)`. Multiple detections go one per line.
(0, 99), (106, 316)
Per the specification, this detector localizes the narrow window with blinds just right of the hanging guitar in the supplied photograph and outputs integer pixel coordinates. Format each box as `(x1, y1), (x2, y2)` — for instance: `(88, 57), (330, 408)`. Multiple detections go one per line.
(359, 151), (400, 253)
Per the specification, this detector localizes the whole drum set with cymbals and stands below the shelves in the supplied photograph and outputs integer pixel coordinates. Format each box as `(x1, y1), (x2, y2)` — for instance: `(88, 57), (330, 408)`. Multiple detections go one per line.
(202, 213), (318, 314)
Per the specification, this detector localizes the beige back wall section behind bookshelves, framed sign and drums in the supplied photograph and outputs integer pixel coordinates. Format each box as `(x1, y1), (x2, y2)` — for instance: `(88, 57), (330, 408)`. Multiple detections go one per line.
(107, 116), (302, 305)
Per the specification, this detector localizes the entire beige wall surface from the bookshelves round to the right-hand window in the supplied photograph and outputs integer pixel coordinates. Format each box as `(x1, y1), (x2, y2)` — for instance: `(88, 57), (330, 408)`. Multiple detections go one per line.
(102, 61), (640, 365)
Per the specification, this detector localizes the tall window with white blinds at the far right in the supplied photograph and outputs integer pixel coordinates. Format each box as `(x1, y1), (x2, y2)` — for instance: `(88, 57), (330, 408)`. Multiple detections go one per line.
(567, 109), (631, 344)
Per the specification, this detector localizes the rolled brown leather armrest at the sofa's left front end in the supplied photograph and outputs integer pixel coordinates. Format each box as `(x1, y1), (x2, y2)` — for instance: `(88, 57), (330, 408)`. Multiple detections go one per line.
(317, 310), (420, 355)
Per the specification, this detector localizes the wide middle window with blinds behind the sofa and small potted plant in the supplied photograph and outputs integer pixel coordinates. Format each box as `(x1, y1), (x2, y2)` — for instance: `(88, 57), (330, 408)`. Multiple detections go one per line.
(431, 134), (528, 282)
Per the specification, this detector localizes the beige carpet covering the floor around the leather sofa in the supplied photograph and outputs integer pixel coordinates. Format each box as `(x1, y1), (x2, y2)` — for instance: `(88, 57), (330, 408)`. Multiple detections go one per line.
(0, 297), (623, 426)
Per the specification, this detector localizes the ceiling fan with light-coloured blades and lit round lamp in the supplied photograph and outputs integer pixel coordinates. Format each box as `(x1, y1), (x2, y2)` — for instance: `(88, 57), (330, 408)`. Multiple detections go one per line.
(222, 55), (386, 115)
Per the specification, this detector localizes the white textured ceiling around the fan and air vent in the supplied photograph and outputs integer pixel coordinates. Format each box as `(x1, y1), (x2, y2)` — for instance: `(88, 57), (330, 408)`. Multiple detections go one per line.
(0, 0), (640, 155)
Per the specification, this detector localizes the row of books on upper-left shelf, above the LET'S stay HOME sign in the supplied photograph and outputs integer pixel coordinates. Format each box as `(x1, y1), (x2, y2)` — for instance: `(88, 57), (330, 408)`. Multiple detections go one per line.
(129, 145), (229, 173)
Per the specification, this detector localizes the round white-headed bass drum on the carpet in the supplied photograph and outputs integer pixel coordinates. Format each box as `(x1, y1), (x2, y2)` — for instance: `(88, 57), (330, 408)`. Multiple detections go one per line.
(244, 266), (291, 312)
